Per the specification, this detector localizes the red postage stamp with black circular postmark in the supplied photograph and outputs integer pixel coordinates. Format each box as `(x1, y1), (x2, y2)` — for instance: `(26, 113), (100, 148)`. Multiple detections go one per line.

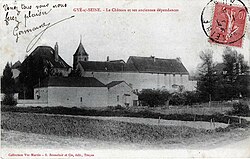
(210, 3), (247, 47)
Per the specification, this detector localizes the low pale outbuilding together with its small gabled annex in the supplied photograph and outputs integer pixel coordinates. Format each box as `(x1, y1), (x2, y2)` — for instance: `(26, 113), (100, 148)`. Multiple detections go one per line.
(34, 77), (138, 107)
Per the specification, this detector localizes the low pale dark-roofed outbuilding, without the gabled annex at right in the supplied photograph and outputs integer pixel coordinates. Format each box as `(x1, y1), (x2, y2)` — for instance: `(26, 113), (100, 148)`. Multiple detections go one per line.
(34, 77), (108, 107)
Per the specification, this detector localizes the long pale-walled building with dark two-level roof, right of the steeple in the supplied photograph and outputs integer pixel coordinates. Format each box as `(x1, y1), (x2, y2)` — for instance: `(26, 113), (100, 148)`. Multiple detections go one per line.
(74, 46), (196, 91)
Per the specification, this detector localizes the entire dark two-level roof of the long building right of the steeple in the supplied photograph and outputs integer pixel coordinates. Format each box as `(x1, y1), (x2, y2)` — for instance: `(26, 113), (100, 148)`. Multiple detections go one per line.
(80, 56), (188, 74)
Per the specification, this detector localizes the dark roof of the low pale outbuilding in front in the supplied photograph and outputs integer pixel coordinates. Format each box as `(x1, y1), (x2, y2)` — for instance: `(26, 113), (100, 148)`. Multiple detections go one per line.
(34, 77), (106, 88)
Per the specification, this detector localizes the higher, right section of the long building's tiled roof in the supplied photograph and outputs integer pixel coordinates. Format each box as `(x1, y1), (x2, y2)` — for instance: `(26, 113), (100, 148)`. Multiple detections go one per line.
(127, 56), (188, 74)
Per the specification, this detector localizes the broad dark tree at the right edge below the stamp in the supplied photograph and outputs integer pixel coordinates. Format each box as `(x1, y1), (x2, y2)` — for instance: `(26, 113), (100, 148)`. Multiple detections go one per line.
(222, 47), (249, 99)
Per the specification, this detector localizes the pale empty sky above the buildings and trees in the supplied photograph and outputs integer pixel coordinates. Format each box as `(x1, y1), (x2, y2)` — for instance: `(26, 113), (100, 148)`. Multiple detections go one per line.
(0, 0), (250, 74)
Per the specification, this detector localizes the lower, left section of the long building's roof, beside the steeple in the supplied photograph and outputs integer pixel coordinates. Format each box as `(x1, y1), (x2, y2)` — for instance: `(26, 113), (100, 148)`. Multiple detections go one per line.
(79, 61), (137, 72)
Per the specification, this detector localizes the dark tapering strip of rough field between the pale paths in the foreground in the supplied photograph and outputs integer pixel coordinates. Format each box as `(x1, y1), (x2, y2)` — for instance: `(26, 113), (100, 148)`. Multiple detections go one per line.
(1, 112), (220, 143)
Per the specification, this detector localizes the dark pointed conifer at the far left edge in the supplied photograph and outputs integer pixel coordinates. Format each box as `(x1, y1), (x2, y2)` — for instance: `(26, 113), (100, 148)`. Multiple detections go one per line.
(1, 63), (15, 94)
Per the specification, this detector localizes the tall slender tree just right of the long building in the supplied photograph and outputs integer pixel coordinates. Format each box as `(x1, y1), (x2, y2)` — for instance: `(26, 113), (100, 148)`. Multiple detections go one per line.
(197, 50), (218, 101)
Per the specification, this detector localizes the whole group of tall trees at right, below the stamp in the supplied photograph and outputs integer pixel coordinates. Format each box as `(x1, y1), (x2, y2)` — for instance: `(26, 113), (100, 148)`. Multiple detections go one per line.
(197, 47), (250, 101)
